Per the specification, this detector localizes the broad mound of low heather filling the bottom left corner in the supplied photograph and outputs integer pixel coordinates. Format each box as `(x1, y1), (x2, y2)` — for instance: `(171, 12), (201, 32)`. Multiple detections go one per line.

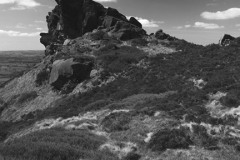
(0, 128), (118, 160)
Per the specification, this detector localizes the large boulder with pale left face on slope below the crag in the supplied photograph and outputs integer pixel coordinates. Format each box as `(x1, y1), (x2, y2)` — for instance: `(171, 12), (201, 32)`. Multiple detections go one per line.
(49, 58), (93, 89)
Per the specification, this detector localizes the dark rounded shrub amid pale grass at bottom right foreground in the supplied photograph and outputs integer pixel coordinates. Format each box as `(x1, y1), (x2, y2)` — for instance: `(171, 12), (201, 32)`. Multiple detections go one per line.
(148, 128), (192, 152)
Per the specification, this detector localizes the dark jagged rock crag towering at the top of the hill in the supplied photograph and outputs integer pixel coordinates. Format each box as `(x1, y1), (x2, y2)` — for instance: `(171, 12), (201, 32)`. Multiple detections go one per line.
(40, 0), (146, 47)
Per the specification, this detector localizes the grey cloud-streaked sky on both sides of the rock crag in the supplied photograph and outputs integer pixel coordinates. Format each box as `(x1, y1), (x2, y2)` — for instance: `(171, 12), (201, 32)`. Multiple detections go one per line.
(0, 0), (240, 50)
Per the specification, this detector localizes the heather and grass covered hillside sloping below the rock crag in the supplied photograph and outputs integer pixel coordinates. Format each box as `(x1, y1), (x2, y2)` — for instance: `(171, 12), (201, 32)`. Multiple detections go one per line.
(0, 35), (240, 160)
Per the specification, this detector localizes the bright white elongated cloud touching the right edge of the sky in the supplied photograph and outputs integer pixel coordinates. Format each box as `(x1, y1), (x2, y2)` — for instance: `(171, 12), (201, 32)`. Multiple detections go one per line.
(201, 8), (240, 20)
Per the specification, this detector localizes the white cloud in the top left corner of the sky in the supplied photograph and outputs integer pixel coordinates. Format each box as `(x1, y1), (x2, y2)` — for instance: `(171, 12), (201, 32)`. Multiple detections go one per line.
(0, 0), (41, 10)
